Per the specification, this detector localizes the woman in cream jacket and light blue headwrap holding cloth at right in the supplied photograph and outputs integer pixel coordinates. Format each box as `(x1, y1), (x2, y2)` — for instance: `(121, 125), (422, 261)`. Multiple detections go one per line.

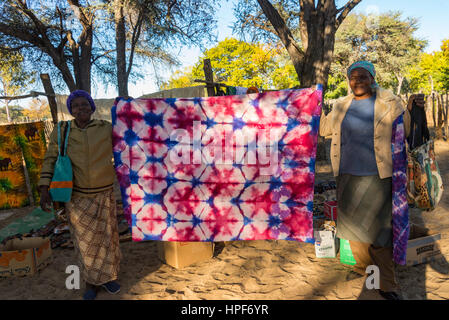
(320, 61), (424, 300)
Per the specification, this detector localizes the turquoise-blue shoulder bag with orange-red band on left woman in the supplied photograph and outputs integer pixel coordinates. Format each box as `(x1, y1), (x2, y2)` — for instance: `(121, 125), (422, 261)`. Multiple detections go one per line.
(50, 121), (73, 202)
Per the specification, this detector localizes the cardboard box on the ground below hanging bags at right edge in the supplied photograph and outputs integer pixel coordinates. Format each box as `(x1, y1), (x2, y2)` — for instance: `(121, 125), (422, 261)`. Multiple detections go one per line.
(407, 234), (441, 266)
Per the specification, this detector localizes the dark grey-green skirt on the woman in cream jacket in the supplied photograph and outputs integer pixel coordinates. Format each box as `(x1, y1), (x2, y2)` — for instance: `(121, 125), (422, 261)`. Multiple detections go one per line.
(337, 174), (393, 247)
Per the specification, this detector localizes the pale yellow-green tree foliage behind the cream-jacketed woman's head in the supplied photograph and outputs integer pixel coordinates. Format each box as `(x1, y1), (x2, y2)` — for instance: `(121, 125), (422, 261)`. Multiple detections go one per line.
(330, 12), (426, 96)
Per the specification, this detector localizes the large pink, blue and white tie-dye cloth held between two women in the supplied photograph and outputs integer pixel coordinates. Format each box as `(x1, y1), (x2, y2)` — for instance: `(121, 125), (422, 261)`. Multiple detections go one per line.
(112, 89), (322, 242)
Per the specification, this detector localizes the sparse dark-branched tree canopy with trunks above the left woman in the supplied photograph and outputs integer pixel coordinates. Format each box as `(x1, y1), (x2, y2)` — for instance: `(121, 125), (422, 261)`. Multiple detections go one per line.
(0, 0), (215, 92)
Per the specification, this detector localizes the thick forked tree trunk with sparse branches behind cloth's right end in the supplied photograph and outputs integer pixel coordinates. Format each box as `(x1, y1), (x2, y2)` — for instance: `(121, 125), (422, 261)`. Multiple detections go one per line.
(234, 0), (362, 89)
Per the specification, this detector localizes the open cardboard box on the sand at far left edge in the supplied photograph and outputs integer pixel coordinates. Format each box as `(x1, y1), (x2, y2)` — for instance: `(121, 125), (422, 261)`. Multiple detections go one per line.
(0, 237), (51, 277)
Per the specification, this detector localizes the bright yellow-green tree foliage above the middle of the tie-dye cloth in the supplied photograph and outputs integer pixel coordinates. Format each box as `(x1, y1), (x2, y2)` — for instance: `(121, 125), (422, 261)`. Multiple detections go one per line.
(161, 38), (299, 89)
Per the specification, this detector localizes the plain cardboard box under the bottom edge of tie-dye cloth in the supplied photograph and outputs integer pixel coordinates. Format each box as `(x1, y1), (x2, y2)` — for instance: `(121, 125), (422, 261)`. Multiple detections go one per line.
(157, 241), (214, 269)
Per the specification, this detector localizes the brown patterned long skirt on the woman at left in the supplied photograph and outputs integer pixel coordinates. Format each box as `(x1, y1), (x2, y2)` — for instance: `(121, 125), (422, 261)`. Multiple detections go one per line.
(66, 189), (121, 285)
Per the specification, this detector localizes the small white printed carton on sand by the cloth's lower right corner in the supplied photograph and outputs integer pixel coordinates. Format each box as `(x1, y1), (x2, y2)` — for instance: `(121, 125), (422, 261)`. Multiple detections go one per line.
(313, 220), (339, 258)
